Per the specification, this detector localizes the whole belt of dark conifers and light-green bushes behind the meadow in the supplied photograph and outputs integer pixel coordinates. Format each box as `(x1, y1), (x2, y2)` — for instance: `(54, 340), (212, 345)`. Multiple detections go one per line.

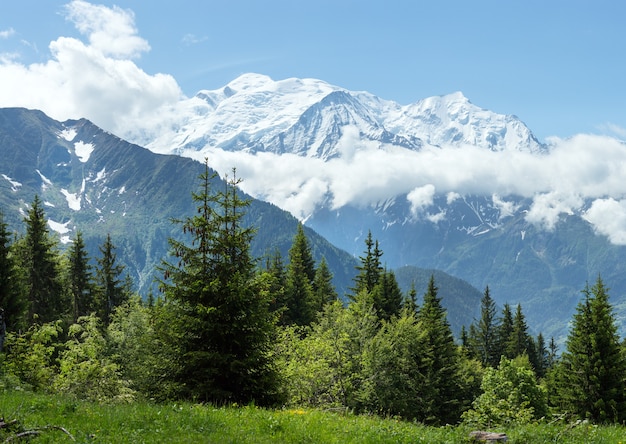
(0, 161), (626, 426)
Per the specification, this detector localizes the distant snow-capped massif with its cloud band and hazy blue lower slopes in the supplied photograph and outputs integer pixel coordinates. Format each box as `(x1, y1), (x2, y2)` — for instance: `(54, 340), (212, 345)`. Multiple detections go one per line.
(120, 74), (626, 344)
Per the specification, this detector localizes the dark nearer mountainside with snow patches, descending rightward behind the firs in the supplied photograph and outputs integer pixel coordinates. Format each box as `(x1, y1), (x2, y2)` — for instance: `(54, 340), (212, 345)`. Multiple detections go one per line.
(0, 108), (481, 333)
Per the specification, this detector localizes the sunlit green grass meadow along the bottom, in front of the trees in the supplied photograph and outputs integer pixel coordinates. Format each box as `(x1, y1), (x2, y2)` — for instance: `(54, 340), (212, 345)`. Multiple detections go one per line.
(0, 392), (626, 444)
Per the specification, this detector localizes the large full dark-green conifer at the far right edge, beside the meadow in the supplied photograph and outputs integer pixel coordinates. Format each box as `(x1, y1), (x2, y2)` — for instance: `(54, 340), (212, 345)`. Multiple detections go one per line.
(558, 276), (626, 423)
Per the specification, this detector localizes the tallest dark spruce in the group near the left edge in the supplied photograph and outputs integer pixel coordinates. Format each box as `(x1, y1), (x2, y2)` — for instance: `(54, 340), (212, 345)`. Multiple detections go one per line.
(20, 196), (65, 324)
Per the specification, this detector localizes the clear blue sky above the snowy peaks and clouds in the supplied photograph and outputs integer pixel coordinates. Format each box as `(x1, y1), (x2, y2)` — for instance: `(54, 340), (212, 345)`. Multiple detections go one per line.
(0, 0), (626, 140)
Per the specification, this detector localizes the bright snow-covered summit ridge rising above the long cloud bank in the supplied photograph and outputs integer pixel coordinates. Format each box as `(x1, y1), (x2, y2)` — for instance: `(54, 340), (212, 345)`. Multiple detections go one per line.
(137, 74), (543, 160)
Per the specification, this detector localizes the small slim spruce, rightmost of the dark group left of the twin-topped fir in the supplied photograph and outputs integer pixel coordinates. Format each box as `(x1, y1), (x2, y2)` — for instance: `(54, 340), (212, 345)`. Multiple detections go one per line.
(96, 234), (130, 326)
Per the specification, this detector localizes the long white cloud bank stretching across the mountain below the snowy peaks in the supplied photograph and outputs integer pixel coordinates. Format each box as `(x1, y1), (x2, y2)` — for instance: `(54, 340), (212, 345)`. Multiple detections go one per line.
(188, 131), (626, 245)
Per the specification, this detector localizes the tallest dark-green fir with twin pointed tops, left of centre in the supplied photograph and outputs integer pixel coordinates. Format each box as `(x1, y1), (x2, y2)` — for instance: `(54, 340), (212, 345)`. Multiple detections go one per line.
(161, 163), (279, 405)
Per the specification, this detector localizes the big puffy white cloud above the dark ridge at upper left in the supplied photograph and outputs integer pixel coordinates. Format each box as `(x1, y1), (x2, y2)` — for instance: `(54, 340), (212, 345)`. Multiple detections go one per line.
(0, 1), (182, 136)
